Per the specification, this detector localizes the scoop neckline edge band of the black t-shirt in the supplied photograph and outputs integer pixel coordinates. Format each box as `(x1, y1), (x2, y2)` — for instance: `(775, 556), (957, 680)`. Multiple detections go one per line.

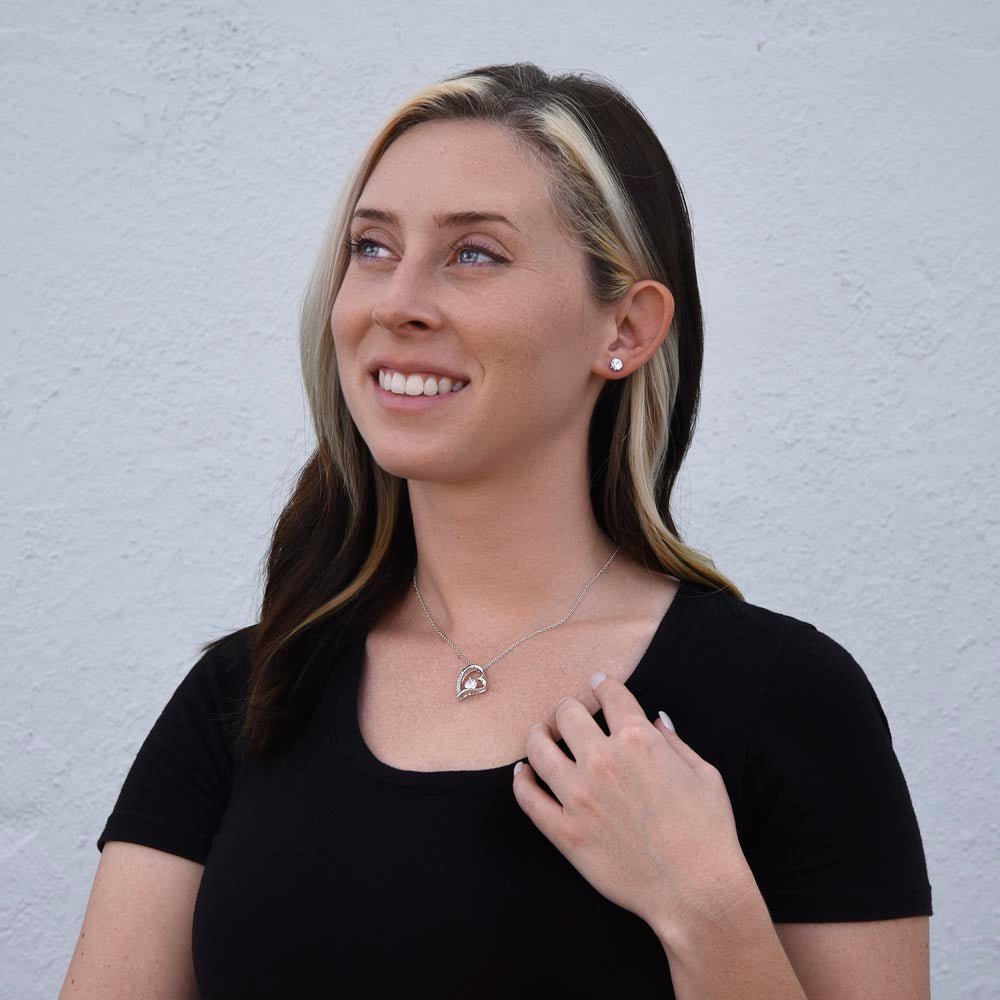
(331, 579), (695, 792)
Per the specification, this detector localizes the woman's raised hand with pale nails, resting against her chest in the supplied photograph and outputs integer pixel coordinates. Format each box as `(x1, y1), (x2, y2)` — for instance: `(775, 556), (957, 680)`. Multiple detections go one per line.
(514, 674), (756, 932)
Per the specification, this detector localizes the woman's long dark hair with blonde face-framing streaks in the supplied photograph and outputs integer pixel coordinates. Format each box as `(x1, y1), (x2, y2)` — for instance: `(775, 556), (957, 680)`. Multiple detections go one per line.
(209, 62), (744, 756)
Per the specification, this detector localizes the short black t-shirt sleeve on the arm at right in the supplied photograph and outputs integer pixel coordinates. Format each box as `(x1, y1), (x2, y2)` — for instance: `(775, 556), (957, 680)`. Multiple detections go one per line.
(741, 623), (933, 923)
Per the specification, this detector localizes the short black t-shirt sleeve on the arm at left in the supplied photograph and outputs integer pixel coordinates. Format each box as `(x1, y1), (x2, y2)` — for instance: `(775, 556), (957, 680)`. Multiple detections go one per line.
(97, 633), (244, 864)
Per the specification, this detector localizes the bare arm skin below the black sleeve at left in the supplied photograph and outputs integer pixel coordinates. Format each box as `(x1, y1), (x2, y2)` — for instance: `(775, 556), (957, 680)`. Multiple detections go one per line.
(59, 840), (205, 1000)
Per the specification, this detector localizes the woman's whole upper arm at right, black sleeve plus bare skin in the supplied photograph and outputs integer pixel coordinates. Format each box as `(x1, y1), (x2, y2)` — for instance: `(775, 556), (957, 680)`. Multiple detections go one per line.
(741, 625), (932, 1000)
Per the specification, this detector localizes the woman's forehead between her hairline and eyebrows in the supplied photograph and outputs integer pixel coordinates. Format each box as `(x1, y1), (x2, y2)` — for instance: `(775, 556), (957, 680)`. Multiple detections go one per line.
(359, 121), (556, 233)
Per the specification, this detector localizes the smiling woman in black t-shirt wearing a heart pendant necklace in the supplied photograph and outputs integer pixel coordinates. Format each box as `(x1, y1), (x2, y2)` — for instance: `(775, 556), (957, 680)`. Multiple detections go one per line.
(63, 64), (932, 1000)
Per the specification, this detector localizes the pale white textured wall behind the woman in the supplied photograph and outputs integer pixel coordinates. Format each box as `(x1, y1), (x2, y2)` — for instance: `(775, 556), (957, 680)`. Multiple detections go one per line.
(0, 0), (1000, 1000)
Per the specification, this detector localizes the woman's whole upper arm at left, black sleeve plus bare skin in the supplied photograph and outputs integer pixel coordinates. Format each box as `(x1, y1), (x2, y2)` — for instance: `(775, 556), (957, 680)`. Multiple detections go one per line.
(69, 643), (248, 1000)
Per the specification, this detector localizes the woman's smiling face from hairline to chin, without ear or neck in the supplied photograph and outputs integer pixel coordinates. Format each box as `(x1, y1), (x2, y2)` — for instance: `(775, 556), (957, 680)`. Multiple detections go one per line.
(331, 122), (615, 483)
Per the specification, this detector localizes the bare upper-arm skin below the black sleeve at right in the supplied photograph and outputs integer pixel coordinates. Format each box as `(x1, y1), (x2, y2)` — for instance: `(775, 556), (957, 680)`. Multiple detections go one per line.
(774, 916), (931, 1000)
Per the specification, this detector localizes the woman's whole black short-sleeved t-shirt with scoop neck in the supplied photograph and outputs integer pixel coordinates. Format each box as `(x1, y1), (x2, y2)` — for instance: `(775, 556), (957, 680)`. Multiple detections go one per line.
(97, 582), (932, 1000)
